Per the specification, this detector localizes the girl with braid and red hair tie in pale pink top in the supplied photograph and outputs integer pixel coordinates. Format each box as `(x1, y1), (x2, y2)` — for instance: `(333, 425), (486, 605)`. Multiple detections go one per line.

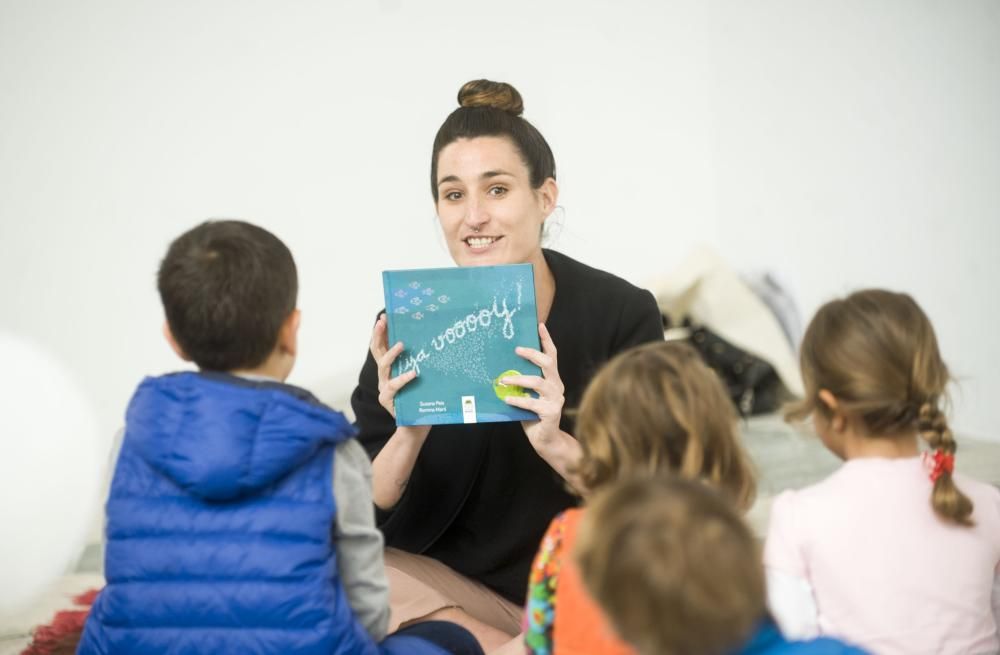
(764, 290), (1000, 655)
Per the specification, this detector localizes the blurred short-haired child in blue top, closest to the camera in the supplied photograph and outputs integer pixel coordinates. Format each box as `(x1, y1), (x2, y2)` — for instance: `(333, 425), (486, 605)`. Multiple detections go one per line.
(575, 477), (864, 655)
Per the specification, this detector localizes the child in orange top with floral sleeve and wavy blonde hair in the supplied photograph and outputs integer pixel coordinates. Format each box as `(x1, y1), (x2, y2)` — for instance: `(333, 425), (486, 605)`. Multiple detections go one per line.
(525, 341), (754, 655)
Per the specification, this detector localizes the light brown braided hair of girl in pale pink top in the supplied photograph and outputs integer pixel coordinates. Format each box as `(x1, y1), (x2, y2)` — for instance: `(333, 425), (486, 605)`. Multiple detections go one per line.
(785, 289), (972, 525)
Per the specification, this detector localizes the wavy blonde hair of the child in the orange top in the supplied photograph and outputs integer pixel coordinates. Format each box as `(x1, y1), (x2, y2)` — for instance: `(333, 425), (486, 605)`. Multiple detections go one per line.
(574, 341), (756, 510)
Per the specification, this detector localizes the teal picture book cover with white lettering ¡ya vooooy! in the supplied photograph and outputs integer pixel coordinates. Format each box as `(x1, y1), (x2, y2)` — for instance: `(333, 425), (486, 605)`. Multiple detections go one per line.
(382, 264), (542, 425)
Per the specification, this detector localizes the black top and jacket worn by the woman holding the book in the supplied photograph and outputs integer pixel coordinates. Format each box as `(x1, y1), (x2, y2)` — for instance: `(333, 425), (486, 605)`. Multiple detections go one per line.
(351, 250), (663, 605)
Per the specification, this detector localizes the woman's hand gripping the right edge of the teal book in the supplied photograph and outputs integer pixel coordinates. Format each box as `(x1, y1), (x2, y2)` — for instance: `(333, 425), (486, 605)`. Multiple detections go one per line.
(501, 323), (566, 459)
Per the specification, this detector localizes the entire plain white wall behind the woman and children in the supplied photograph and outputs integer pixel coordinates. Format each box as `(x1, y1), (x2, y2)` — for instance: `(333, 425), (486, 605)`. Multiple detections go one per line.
(0, 0), (1000, 454)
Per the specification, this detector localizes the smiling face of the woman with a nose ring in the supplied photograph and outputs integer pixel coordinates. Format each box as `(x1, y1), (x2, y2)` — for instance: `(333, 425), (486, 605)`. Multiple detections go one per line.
(437, 136), (558, 266)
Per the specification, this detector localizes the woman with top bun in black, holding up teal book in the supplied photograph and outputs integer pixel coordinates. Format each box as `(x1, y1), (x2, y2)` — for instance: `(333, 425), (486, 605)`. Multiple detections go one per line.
(352, 80), (663, 650)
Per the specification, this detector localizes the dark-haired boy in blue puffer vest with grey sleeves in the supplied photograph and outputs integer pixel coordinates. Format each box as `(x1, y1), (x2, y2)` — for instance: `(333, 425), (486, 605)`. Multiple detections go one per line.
(79, 221), (481, 655)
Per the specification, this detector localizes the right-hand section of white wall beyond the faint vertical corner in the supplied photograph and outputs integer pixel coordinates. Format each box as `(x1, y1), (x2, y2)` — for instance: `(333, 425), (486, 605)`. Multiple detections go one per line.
(711, 0), (1000, 439)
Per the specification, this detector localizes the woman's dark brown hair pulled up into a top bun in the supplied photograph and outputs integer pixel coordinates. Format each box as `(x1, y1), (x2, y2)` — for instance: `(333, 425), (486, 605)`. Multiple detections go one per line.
(431, 80), (556, 202)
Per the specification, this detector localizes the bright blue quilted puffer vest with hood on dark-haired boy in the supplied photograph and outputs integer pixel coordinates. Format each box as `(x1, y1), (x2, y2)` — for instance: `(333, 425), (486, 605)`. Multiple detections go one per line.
(78, 373), (380, 655)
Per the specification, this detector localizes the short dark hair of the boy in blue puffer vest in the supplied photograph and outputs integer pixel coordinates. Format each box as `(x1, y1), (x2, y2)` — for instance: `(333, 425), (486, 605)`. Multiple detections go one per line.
(157, 220), (298, 371)
